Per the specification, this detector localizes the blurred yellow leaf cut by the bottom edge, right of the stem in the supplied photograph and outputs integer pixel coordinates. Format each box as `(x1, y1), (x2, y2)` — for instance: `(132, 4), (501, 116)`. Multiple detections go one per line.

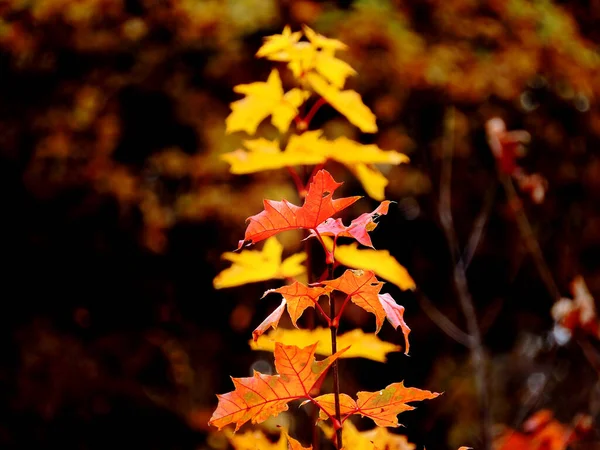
(319, 420), (417, 450)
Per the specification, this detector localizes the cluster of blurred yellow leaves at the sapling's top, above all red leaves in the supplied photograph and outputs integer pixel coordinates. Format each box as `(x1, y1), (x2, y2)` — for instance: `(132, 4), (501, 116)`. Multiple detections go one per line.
(223, 26), (408, 200)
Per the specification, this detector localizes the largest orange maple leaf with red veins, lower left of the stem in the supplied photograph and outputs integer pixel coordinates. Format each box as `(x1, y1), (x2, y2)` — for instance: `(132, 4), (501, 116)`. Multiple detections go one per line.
(208, 343), (347, 431)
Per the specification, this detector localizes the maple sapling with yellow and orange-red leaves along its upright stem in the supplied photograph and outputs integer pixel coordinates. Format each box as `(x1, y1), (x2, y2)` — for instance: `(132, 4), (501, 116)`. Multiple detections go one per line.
(209, 26), (439, 450)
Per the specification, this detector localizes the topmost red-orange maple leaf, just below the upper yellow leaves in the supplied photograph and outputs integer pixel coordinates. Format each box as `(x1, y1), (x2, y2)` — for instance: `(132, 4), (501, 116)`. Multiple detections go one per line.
(238, 169), (360, 249)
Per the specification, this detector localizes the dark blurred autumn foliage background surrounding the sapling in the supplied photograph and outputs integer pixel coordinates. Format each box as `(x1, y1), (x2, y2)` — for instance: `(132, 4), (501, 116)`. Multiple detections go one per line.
(0, 0), (600, 449)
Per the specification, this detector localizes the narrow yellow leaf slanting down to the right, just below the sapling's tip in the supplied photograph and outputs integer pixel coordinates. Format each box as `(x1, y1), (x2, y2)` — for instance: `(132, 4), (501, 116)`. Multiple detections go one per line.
(306, 72), (377, 133)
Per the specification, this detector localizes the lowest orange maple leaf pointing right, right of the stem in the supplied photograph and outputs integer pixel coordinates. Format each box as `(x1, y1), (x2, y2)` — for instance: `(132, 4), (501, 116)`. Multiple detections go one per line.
(315, 382), (440, 427)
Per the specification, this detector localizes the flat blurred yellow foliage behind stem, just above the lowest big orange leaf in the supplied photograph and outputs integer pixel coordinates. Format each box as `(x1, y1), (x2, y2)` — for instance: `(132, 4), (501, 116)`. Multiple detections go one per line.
(249, 327), (401, 362)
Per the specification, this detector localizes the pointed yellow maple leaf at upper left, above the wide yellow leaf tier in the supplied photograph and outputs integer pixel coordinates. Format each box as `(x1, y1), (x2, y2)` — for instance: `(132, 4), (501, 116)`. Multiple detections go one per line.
(225, 69), (310, 135)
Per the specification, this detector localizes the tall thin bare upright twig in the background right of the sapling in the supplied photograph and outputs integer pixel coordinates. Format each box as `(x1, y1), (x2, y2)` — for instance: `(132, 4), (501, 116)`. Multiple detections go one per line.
(439, 107), (492, 450)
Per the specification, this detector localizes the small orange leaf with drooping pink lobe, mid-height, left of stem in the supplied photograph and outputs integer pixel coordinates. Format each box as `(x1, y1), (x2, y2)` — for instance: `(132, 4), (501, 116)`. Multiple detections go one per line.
(252, 281), (329, 340)
